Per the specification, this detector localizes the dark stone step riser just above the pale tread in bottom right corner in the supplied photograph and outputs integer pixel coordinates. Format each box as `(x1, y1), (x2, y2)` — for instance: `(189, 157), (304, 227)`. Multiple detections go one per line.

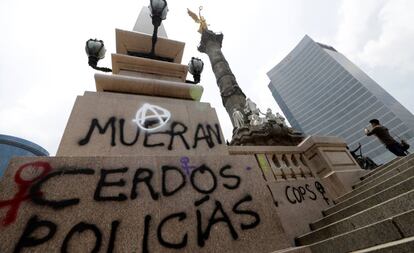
(302, 211), (414, 253)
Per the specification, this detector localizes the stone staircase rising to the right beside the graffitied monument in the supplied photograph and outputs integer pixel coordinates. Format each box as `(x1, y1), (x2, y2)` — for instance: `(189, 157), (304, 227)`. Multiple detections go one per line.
(277, 154), (414, 253)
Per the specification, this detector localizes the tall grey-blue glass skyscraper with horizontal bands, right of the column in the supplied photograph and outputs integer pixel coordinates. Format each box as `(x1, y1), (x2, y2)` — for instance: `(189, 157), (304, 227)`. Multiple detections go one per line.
(267, 35), (414, 163)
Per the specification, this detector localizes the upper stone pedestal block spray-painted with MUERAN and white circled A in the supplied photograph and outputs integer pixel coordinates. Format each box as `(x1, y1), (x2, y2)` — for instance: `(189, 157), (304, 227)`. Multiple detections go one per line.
(57, 92), (227, 156)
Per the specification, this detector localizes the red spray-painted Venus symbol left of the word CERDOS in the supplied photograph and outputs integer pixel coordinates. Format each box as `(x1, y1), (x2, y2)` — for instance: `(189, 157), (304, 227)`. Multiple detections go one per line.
(0, 162), (52, 226)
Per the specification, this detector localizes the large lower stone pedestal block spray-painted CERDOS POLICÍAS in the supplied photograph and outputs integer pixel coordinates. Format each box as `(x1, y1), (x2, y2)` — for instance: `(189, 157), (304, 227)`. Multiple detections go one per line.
(0, 156), (290, 252)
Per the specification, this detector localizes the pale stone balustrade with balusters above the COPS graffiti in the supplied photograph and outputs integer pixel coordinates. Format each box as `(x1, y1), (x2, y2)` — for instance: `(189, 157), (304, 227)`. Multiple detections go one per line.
(229, 136), (365, 197)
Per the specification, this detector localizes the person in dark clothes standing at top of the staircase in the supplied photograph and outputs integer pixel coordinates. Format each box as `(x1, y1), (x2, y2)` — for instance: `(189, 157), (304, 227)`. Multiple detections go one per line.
(364, 119), (406, 156)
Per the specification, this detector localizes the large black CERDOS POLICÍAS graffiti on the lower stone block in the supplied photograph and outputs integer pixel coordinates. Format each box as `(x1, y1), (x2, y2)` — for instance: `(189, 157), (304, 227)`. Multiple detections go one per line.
(0, 156), (262, 252)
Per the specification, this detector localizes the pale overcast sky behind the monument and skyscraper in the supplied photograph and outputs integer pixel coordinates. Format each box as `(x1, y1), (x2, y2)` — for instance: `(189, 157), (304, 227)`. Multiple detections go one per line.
(0, 0), (414, 155)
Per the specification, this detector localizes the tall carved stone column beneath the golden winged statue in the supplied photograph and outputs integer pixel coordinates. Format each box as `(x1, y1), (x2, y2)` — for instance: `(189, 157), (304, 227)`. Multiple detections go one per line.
(198, 30), (246, 126)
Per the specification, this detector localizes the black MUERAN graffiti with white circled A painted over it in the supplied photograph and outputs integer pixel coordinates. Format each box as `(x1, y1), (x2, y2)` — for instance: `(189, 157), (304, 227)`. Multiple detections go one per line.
(76, 103), (223, 150)
